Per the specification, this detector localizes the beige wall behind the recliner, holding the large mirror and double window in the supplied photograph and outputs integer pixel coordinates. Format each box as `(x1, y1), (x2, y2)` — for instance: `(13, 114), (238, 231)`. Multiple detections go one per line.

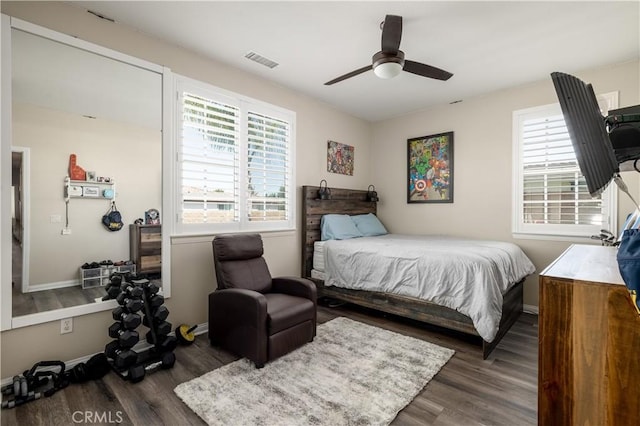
(0, 2), (371, 377)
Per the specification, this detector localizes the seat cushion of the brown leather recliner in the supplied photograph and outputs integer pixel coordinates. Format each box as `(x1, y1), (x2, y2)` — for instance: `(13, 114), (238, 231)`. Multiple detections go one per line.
(264, 293), (315, 335)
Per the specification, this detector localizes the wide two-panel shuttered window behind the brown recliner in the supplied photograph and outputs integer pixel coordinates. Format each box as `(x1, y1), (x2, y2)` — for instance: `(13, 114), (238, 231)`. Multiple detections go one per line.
(176, 77), (295, 234)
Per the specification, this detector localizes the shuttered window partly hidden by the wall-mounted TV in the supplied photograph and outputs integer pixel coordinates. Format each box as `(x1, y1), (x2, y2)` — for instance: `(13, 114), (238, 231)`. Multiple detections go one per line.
(513, 93), (618, 237)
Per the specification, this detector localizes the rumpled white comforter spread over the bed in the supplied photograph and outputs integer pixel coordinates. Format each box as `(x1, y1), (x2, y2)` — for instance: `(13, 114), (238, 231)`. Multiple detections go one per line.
(324, 234), (535, 342)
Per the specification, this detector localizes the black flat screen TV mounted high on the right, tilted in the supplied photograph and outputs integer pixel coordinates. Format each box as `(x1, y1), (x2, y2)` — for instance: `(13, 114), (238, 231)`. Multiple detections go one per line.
(551, 72), (620, 197)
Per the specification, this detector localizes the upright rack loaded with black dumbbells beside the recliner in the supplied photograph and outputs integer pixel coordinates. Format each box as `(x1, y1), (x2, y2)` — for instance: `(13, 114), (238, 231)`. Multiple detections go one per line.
(105, 273), (177, 383)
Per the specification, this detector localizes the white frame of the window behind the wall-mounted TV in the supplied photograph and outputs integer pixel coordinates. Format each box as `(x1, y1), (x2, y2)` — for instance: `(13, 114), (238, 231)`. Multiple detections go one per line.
(511, 91), (618, 239)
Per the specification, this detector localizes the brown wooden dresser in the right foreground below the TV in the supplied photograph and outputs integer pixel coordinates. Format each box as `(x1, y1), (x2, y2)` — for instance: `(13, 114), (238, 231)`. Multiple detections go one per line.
(538, 245), (640, 426)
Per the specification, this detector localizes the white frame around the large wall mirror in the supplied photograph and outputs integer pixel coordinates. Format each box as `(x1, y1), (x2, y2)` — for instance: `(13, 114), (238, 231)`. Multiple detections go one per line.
(0, 14), (174, 331)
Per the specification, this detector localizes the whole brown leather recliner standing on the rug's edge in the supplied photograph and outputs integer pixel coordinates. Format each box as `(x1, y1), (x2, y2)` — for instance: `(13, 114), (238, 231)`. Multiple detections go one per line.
(209, 234), (317, 368)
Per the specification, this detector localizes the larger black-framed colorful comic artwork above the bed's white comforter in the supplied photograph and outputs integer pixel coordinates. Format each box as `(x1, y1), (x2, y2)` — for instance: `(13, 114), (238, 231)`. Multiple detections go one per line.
(407, 132), (453, 203)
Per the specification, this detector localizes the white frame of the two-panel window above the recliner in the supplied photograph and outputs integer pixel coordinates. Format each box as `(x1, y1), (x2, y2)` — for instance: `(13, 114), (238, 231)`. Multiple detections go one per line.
(170, 74), (296, 236)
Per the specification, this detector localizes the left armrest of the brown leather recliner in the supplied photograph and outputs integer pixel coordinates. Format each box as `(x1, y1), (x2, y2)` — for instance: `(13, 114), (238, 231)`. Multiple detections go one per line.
(209, 288), (267, 326)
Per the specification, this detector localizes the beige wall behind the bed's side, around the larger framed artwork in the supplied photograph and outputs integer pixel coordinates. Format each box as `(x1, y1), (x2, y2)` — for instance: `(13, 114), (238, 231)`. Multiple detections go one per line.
(371, 61), (640, 306)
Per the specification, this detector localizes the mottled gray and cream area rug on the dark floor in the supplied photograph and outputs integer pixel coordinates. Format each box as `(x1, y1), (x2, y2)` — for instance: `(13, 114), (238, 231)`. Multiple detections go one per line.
(174, 318), (454, 426)
